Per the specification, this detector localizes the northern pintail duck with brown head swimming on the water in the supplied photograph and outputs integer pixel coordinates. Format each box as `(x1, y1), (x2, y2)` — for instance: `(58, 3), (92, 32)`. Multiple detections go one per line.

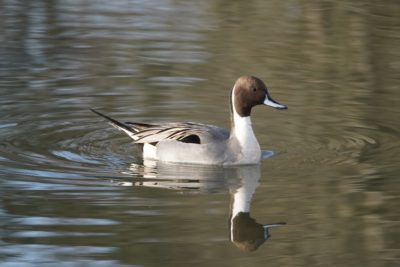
(92, 76), (287, 165)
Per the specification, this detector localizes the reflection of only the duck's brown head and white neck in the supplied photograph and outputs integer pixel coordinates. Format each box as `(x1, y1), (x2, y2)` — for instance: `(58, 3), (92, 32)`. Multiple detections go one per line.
(229, 165), (285, 251)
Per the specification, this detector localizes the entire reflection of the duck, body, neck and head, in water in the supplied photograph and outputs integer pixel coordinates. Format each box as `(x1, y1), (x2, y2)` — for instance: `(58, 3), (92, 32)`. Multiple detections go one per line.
(125, 162), (285, 251)
